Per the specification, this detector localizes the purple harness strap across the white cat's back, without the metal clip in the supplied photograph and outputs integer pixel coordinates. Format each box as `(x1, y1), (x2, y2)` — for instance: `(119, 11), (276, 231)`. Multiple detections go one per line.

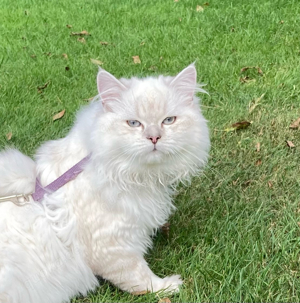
(32, 155), (91, 201)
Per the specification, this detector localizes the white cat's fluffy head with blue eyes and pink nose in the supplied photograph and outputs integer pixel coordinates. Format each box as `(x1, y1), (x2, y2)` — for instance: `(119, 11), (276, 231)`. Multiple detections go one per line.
(93, 64), (210, 183)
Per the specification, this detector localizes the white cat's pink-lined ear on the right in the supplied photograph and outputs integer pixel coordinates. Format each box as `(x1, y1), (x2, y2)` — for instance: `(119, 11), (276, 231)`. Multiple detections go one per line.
(170, 63), (197, 102)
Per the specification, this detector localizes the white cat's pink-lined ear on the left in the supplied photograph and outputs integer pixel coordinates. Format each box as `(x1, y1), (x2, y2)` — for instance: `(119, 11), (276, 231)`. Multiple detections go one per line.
(97, 68), (126, 111)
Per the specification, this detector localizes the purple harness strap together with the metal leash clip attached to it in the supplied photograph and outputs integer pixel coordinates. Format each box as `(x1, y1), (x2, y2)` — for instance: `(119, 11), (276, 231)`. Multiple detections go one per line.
(0, 154), (91, 206)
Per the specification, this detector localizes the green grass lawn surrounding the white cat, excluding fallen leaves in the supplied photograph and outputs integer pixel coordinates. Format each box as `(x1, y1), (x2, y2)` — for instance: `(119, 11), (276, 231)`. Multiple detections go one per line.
(0, 0), (300, 302)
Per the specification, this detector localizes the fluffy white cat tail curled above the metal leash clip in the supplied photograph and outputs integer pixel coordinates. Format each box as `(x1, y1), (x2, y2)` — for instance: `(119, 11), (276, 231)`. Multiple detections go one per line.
(0, 149), (36, 197)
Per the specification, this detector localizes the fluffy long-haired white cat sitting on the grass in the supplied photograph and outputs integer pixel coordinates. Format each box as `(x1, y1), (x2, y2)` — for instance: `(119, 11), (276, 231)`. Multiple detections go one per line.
(0, 64), (210, 303)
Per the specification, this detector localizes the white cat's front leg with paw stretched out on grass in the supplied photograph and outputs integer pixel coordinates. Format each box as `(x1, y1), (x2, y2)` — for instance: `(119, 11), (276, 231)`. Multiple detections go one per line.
(95, 250), (182, 293)
